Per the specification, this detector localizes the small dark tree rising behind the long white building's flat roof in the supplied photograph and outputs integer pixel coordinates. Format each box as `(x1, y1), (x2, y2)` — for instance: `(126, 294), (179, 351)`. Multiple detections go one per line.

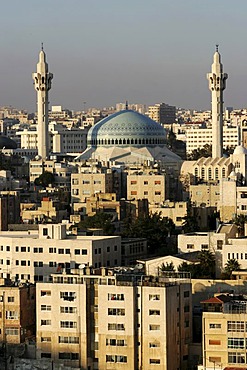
(78, 212), (115, 235)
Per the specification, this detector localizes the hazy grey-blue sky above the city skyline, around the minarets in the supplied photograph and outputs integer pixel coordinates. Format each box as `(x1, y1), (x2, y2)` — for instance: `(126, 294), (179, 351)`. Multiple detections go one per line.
(0, 0), (247, 111)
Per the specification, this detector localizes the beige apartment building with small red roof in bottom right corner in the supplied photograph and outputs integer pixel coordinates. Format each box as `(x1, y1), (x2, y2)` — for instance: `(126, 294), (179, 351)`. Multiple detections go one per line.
(201, 294), (247, 370)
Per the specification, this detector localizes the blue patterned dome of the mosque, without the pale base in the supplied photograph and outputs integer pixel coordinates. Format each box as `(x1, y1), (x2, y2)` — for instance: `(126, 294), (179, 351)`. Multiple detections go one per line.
(87, 110), (166, 147)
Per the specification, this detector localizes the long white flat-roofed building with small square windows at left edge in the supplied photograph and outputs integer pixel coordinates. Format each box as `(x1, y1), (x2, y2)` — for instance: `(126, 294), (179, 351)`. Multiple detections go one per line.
(0, 224), (121, 282)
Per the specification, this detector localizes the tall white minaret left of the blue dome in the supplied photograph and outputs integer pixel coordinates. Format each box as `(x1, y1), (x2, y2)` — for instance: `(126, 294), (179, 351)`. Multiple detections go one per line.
(32, 44), (53, 159)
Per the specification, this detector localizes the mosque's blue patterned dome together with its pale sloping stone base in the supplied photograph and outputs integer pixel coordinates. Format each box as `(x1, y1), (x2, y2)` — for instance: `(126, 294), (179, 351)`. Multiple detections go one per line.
(76, 107), (182, 169)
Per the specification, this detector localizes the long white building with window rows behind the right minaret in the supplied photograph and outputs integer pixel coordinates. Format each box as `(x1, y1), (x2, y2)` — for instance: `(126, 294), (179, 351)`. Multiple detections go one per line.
(186, 126), (241, 153)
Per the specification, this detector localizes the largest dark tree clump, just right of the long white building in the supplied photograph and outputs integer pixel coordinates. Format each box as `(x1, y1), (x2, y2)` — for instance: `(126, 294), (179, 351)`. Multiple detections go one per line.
(123, 212), (176, 255)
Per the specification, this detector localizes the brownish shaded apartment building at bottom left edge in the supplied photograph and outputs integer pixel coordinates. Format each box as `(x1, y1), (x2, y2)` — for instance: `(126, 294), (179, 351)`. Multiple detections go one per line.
(0, 279), (36, 344)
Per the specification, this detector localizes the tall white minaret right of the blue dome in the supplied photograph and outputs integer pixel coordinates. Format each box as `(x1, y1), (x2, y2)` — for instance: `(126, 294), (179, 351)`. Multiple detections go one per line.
(207, 45), (228, 158)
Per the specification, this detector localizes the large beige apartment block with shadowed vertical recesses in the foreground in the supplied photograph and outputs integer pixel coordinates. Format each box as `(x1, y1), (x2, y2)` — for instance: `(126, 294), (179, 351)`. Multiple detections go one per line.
(37, 268), (192, 370)
